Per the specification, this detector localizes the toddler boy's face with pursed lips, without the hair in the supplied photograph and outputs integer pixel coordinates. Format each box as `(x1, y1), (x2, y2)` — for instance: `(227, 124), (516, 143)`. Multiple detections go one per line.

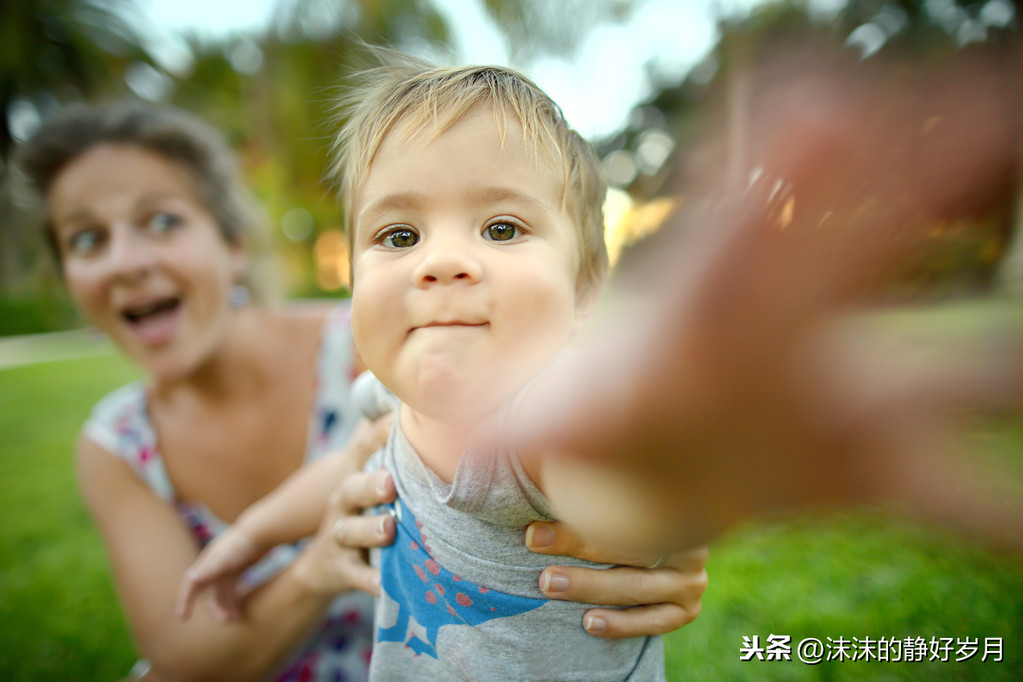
(352, 107), (583, 421)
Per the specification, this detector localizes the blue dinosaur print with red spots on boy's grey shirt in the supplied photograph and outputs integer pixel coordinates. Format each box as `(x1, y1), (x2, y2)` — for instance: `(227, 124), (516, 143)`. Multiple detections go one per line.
(376, 500), (546, 658)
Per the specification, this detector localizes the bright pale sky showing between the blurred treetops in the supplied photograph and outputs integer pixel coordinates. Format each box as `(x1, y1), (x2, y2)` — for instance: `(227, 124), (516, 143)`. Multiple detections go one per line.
(139, 0), (843, 139)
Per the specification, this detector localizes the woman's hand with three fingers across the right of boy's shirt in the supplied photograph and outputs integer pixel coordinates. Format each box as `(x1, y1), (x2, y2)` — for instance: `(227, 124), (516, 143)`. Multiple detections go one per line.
(526, 521), (707, 639)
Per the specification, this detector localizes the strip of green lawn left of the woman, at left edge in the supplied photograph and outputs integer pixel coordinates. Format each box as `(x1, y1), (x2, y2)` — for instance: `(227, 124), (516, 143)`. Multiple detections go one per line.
(0, 357), (141, 681)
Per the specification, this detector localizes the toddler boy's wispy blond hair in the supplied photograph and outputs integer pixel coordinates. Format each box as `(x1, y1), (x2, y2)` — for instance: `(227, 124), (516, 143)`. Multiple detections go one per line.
(329, 48), (608, 291)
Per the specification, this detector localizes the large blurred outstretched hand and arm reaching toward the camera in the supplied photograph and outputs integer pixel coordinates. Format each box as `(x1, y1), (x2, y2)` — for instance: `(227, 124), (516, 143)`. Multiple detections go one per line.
(537, 46), (1023, 548)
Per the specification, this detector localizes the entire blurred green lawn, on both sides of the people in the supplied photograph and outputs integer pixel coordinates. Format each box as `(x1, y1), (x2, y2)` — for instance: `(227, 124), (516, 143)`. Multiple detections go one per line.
(0, 349), (1023, 681)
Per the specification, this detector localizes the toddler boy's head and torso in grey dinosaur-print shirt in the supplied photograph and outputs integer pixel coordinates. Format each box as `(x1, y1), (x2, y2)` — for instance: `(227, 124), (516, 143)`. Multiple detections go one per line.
(181, 54), (664, 680)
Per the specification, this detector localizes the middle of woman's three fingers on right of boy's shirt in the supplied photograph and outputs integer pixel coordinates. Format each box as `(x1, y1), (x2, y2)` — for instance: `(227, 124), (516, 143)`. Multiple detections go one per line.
(540, 566), (706, 606)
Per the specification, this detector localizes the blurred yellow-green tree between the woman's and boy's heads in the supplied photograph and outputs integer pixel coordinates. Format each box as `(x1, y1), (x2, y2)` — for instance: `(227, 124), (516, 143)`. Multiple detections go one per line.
(201, 0), (458, 295)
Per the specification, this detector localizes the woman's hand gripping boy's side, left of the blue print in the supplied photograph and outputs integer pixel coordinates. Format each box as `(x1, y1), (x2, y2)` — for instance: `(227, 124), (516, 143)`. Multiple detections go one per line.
(295, 470), (398, 594)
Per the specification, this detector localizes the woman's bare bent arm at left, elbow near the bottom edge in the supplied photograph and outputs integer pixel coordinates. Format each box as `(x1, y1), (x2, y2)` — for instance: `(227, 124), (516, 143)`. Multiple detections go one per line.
(78, 436), (393, 680)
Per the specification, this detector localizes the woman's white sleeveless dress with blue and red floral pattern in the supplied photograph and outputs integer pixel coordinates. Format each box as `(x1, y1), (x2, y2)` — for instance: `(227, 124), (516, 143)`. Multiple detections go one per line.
(85, 305), (373, 682)
